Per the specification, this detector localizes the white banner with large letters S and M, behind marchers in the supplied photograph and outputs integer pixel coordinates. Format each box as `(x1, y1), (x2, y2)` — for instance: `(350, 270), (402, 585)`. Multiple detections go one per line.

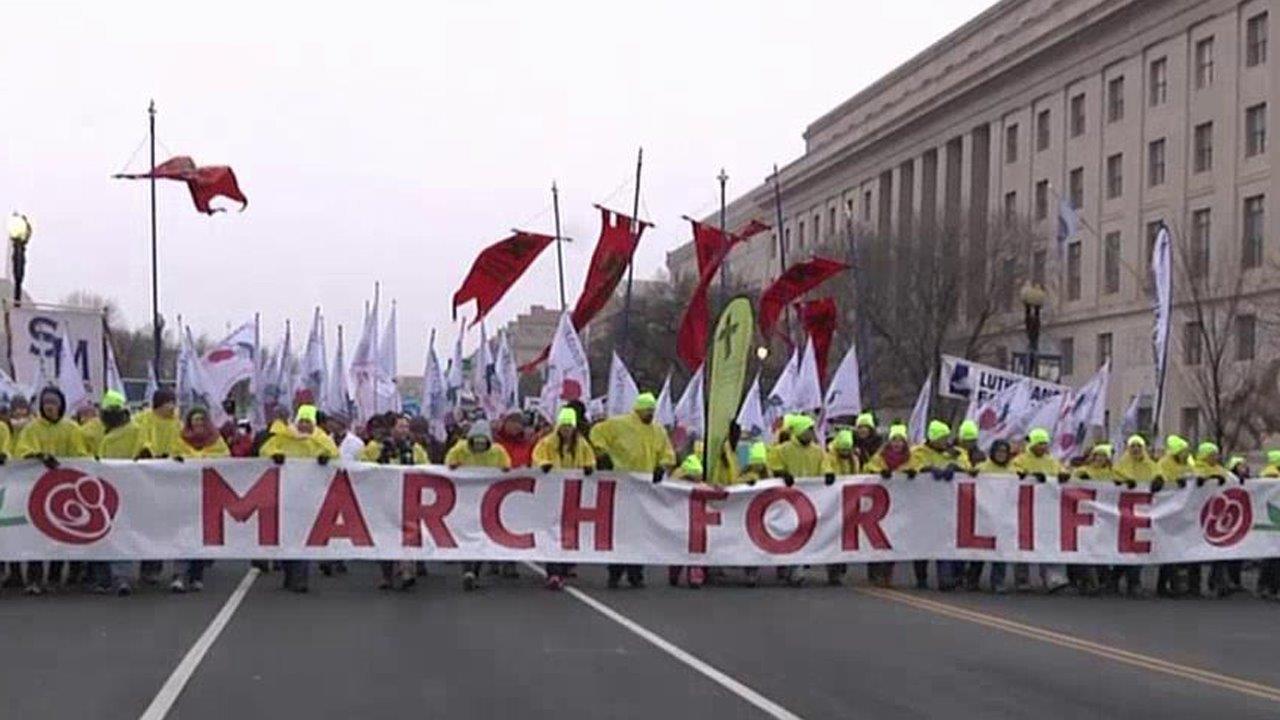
(9, 304), (105, 398)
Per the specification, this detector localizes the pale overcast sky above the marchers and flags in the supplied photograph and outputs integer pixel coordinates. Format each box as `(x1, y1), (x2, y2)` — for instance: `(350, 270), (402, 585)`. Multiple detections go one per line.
(0, 0), (991, 374)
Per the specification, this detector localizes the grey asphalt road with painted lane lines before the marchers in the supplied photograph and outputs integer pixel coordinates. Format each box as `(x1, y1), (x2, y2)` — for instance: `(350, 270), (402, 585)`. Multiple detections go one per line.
(0, 562), (1280, 720)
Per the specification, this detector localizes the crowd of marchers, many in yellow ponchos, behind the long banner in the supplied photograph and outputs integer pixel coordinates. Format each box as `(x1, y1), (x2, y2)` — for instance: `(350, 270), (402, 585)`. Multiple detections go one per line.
(0, 387), (1280, 600)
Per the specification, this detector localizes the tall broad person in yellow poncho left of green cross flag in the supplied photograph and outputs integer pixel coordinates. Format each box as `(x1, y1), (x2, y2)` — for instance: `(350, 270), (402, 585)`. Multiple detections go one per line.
(590, 392), (676, 589)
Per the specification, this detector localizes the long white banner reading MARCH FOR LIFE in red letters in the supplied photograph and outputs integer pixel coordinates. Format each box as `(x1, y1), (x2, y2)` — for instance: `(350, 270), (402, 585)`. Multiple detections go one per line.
(0, 460), (1280, 565)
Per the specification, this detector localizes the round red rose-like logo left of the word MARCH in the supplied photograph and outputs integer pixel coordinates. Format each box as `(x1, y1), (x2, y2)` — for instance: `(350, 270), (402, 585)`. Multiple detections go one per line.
(27, 468), (120, 544)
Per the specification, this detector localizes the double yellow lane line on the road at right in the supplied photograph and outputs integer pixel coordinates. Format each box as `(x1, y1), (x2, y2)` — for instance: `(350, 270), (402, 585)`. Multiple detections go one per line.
(858, 588), (1280, 702)
